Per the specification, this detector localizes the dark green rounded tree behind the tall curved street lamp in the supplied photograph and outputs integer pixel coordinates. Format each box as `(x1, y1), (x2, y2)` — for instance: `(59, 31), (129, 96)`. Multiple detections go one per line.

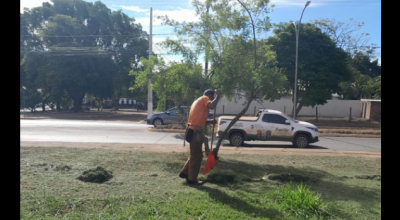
(267, 23), (351, 115)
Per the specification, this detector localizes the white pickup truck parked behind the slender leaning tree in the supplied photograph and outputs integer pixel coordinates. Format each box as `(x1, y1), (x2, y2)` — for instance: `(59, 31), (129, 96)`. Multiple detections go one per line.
(217, 109), (318, 148)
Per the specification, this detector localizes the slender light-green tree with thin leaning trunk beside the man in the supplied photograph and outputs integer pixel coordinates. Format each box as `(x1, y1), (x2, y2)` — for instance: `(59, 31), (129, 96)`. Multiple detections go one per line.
(155, 0), (286, 156)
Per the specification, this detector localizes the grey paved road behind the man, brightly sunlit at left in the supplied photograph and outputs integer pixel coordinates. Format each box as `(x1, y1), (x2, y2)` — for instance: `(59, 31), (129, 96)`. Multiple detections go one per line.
(20, 119), (381, 152)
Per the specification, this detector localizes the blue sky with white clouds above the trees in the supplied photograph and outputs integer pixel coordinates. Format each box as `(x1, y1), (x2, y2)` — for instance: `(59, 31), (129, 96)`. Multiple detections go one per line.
(20, 0), (381, 64)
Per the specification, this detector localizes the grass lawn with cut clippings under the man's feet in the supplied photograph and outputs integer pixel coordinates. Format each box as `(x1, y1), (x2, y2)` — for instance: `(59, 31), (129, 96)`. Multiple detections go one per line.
(20, 147), (381, 220)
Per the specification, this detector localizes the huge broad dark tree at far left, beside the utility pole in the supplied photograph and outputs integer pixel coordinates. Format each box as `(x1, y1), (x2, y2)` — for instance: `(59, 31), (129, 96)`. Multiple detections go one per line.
(20, 0), (148, 111)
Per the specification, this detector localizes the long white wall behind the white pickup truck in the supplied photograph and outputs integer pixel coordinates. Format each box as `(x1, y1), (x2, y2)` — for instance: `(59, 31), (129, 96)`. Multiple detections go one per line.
(216, 97), (362, 118)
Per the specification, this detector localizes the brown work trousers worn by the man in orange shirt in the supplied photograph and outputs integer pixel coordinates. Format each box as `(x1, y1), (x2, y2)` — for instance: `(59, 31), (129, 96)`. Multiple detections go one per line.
(181, 130), (204, 181)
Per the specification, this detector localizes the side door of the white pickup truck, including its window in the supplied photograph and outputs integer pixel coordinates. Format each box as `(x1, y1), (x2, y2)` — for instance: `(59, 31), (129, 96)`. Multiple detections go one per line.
(262, 114), (292, 141)
